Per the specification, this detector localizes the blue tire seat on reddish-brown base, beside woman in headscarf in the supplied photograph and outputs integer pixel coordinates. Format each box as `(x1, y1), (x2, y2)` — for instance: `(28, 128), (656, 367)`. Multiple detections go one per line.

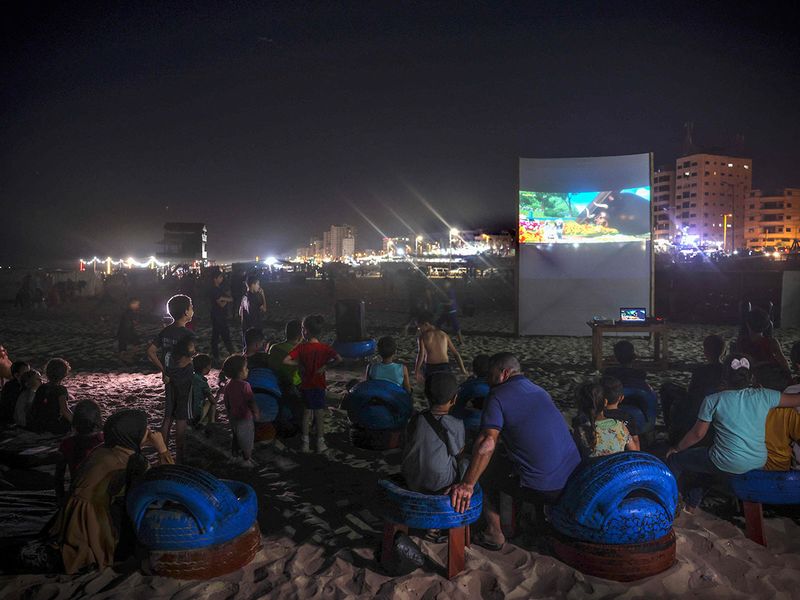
(127, 465), (261, 579)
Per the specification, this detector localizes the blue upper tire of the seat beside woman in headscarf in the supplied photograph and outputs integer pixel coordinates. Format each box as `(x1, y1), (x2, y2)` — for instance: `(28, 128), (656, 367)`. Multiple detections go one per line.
(126, 465), (258, 548)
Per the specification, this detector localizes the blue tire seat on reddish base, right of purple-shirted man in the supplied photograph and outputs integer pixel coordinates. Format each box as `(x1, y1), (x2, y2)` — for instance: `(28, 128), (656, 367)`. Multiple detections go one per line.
(550, 452), (678, 581)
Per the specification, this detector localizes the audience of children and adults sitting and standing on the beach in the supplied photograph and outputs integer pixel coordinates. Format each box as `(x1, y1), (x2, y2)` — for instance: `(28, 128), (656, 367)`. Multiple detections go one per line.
(0, 274), (800, 573)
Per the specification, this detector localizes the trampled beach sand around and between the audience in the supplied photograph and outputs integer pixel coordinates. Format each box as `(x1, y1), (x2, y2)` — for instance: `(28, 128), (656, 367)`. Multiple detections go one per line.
(0, 280), (800, 600)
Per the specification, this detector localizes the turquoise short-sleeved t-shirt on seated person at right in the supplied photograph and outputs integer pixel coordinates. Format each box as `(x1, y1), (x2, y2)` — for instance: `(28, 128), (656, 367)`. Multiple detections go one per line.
(697, 388), (781, 474)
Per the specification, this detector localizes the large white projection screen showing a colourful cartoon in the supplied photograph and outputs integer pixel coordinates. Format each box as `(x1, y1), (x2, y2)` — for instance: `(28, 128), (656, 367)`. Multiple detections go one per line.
(517, 154), (652, 336)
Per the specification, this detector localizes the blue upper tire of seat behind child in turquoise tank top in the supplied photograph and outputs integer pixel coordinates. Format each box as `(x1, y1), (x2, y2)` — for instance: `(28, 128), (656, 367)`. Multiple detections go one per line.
(344, 379), (414, 429)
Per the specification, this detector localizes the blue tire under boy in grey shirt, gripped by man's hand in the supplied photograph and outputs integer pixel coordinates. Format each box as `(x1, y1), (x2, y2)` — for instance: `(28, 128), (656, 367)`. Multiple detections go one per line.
(378, 479), (483, 529)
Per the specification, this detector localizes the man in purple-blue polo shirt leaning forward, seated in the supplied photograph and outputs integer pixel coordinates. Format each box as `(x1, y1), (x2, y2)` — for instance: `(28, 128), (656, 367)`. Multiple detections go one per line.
(450, 352), (581, 550)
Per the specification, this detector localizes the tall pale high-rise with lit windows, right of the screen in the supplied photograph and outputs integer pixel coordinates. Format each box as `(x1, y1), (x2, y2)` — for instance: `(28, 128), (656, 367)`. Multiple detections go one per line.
(674, 153), (753, 250)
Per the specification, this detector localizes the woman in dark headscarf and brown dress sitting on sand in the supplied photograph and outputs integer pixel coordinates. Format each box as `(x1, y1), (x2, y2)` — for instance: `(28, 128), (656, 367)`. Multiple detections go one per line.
(51, 409), (174, 574)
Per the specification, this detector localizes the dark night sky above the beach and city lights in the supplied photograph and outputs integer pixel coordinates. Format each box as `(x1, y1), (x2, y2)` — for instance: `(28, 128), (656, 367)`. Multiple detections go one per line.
(0, 1), (800, 264)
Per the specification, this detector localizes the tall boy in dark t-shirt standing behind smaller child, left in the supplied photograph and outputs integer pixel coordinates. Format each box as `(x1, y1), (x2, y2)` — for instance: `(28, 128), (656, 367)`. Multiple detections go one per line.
(147, 294), (194, 462)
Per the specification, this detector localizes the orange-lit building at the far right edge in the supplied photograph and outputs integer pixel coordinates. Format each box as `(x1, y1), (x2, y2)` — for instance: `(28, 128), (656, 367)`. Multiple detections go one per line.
(741, 188), (800, 250)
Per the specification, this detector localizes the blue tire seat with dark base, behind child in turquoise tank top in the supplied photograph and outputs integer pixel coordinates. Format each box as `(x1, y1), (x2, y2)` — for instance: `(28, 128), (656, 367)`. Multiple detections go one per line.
(343, 379), (414, 450)
